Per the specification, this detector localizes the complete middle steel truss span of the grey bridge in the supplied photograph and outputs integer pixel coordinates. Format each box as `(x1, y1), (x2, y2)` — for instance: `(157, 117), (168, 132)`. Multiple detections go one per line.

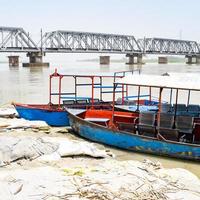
(40, 31), (141, 54)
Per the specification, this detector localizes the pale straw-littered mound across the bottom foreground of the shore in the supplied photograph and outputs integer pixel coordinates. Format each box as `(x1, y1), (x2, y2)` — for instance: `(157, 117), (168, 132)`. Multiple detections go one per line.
(0, 159), (200, 200)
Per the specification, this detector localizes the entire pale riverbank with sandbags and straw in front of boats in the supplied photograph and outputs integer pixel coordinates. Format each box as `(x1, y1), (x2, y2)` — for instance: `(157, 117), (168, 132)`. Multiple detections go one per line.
(0, 108), (200, 200)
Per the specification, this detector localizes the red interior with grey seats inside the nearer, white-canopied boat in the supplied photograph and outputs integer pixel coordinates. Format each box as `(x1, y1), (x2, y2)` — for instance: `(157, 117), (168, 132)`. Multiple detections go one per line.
(78, 106), (200, 144)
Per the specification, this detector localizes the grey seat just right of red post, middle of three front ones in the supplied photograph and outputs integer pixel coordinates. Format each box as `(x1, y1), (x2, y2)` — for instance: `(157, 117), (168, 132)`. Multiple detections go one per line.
(157, 113), (179, 141)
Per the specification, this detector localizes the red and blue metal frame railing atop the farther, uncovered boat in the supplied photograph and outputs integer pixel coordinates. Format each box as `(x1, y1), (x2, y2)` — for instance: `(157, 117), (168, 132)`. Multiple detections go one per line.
(49, 70), (140, 105)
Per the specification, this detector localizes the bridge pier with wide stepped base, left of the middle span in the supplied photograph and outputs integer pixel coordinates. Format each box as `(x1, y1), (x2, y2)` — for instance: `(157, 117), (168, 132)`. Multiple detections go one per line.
(22, 52), (49, 67)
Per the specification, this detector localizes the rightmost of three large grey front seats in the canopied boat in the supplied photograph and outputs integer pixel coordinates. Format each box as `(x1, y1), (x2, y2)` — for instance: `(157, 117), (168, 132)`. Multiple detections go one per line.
(175, 115), (194, 142)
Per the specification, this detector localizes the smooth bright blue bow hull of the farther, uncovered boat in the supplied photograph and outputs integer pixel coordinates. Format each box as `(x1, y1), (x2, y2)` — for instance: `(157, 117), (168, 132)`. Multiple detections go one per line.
(15, 105), (69, 126)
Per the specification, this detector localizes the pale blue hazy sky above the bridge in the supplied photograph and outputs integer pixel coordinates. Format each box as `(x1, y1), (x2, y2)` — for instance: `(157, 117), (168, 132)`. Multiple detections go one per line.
(0, 0), (200, 41)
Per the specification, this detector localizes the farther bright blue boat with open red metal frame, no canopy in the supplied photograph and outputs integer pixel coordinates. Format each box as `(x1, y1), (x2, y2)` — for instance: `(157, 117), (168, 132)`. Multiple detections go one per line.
(13, 70), (138, 126)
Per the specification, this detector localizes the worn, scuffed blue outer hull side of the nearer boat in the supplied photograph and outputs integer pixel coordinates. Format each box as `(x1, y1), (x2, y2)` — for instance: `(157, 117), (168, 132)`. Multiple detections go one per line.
(69, 112), (200, 161)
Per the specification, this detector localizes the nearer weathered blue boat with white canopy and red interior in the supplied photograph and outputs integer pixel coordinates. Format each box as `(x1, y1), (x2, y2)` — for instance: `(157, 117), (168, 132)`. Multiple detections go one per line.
(68, 75), (200, 161)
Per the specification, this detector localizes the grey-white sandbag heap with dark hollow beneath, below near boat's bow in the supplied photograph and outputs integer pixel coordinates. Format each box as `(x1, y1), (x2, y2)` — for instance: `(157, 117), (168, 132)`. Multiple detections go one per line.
(0, 136), (112, 167)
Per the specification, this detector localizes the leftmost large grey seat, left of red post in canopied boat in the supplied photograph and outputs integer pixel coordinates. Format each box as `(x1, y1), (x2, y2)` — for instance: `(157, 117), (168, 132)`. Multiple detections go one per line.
(137, 112), (156, 137)
